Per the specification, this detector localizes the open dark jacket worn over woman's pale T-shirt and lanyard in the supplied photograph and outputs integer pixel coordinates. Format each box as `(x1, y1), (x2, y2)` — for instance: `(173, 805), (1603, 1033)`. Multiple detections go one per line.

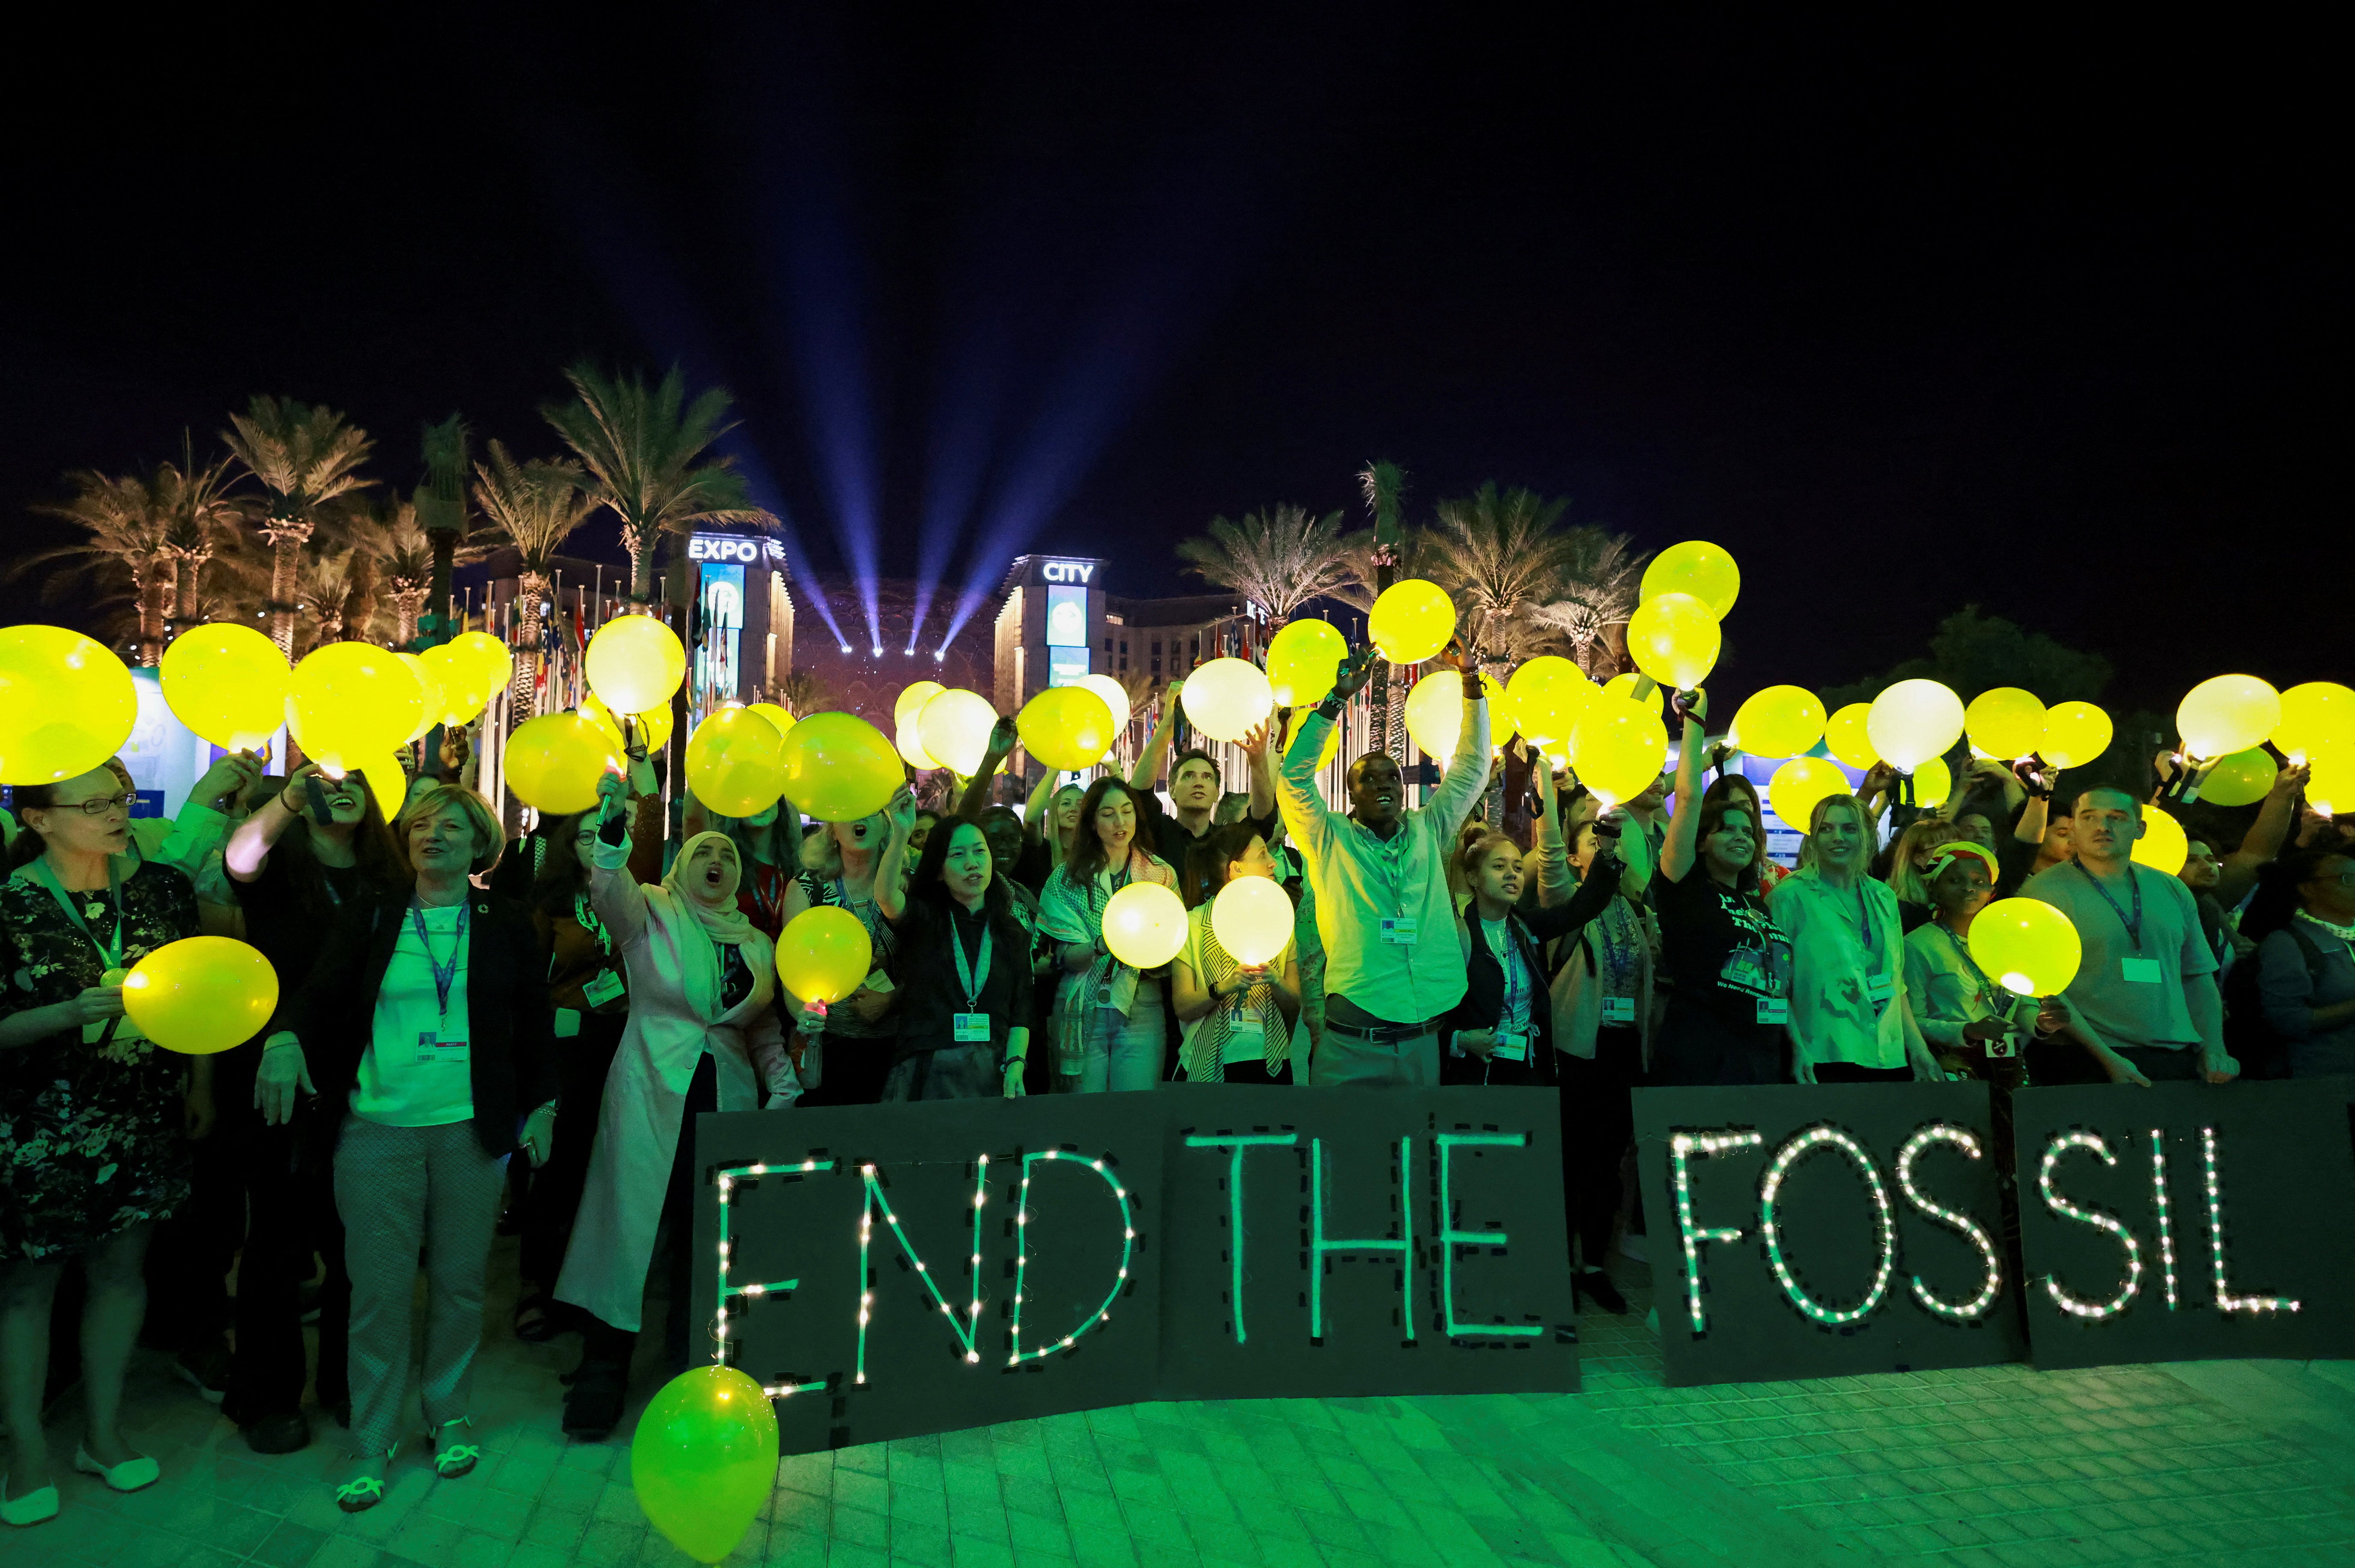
(280, 888), (556, 1154)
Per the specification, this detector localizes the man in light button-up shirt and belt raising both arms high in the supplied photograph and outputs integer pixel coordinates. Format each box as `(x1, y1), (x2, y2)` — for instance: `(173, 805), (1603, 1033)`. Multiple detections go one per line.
(1281, 645), (1488, 1088)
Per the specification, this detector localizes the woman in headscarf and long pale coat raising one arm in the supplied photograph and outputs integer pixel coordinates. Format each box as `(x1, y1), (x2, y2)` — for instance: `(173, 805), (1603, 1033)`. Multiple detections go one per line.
(556, 775), (801, 1441)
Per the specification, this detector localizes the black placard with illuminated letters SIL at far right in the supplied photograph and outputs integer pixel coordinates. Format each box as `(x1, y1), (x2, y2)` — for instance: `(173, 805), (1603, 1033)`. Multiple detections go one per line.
(2018, 1078), (2355, 1368)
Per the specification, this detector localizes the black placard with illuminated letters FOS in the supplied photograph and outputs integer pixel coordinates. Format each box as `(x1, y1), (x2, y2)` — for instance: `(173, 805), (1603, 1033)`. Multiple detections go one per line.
(1634, 1083), (2023, 1387)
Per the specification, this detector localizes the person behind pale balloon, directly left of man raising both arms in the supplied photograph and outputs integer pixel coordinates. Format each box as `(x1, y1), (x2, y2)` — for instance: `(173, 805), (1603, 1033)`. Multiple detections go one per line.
(1171, 822), (1300, 1083)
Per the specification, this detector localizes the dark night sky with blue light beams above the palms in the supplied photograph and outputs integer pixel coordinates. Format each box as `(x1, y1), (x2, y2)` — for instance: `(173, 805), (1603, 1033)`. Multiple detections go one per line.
(0, 5), (2355, 709)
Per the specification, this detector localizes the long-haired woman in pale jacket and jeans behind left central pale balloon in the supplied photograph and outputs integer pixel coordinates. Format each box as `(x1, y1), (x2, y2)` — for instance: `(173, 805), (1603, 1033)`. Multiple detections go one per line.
(1039, 775), (1178, 1095)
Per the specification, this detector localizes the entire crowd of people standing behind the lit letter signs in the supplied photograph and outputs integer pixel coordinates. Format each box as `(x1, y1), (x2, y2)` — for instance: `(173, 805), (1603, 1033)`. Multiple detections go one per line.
(0, 631), (2355, 1523)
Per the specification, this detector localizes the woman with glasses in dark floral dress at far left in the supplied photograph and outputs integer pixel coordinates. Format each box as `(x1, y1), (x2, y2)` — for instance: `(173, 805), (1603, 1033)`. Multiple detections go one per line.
(0, 768), (212, 1526)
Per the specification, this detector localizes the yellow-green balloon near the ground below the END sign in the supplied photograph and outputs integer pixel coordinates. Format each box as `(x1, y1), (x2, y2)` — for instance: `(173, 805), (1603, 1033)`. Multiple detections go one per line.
(629, 1356), (777, 1563)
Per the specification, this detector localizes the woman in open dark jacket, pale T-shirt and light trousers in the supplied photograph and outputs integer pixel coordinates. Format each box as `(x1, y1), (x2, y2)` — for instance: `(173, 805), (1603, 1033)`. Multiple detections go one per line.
(257, 784), (556, 1514)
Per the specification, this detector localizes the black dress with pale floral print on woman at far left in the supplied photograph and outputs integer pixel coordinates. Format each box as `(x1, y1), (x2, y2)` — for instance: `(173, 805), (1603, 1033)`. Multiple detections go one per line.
(0, 862), (198, 1260)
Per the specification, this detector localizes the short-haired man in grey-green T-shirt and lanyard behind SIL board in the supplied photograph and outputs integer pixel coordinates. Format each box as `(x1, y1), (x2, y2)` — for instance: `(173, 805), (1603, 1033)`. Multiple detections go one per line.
(2021, 786), (2240, 1083)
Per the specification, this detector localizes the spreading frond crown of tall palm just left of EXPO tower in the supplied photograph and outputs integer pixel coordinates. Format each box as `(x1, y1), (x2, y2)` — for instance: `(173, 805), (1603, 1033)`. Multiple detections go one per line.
(540, 363), (777, 605)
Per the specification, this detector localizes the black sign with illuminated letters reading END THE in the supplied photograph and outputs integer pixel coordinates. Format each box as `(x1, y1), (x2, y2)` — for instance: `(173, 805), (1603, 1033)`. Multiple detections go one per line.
(697, 1085), (1578, 1453)
